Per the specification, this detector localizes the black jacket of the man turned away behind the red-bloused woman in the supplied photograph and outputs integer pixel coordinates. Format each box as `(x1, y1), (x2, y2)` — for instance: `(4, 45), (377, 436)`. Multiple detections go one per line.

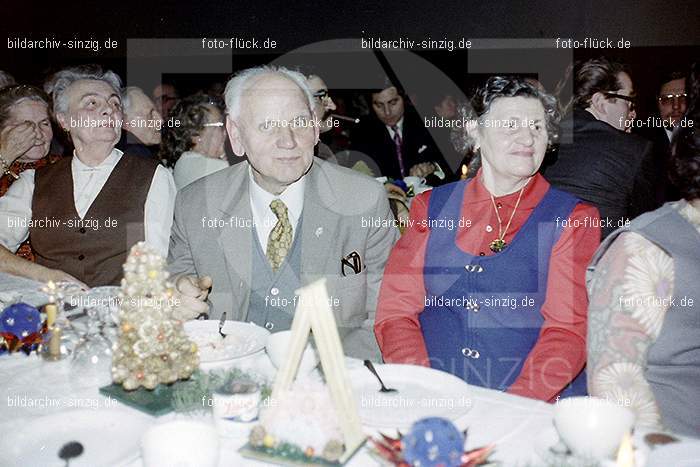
(542, 110), (658, 238)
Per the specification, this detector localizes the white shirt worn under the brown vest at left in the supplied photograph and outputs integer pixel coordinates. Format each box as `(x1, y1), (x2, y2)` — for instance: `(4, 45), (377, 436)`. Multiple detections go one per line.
(0, 149), (177, 258)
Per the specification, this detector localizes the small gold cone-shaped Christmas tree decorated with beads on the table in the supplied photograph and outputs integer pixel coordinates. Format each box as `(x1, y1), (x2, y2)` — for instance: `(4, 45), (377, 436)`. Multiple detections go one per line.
(112, 242), (199, 391)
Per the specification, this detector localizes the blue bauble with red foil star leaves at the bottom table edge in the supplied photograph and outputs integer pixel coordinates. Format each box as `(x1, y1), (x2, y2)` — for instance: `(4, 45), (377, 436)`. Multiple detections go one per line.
(370, 417), (494, 467)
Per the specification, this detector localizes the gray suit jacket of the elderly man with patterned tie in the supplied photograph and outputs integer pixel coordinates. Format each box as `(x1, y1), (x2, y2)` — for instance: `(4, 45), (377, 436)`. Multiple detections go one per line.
(168, 158), (398, 361)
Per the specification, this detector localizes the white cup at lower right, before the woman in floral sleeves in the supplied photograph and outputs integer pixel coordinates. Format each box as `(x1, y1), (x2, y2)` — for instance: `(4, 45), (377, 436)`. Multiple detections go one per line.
(554, 396), (635, 461)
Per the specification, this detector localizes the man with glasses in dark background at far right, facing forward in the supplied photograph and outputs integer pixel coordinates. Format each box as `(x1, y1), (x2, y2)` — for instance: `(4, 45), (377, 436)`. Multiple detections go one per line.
(639, 71), (686, 204)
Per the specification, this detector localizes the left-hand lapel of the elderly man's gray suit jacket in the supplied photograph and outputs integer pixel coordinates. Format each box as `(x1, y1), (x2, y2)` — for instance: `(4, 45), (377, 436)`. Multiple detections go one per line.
(218, 162), (253, 321)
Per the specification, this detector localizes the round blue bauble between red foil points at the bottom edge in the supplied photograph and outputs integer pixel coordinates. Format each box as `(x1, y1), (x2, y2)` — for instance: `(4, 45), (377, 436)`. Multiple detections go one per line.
(402, 417), (464, 467)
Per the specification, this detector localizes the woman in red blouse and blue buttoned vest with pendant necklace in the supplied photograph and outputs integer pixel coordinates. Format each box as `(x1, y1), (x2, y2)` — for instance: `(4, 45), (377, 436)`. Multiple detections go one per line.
(375, 77), (600, 401)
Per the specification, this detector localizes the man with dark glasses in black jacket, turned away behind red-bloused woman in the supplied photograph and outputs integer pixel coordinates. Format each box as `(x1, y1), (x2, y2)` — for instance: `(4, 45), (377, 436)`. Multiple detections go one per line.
(543, 58), (658, 238)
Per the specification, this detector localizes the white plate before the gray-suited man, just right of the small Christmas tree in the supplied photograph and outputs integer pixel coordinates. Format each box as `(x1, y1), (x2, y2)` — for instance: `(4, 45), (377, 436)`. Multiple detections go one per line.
(185, 320), (270, 363)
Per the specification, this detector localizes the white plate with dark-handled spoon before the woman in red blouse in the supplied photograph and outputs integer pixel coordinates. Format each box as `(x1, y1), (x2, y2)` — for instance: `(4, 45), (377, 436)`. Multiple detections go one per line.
(348, 364), (473, 429)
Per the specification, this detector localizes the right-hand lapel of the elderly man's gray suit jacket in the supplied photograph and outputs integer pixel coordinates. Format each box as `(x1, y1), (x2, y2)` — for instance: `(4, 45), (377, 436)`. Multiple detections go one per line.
(301, 158), (342, 283)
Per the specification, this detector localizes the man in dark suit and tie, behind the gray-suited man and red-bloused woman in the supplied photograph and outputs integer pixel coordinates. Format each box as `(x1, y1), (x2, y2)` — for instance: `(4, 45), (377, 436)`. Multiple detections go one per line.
(351, 85), (449, 179)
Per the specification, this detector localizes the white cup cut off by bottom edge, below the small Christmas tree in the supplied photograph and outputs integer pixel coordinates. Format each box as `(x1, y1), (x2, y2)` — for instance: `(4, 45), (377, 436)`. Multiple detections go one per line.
(141, 420), (219, 467)
